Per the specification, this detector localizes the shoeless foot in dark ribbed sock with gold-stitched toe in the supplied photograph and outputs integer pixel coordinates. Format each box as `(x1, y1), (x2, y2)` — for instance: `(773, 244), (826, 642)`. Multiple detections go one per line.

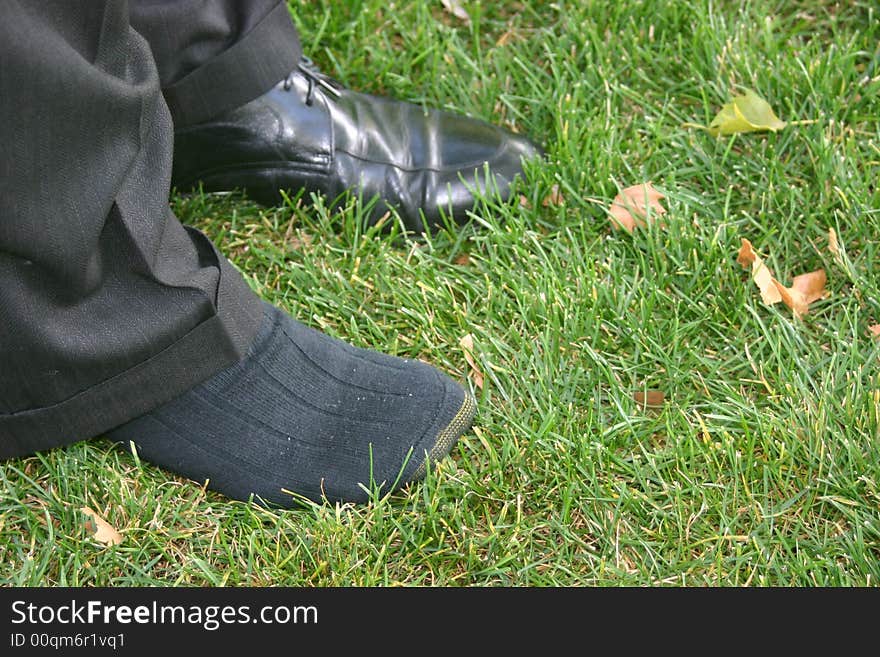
(108, 304), (476, 506)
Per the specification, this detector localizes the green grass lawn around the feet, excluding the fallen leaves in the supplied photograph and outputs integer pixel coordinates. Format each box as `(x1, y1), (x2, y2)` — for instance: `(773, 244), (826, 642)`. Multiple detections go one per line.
(0, 0), (880, 586)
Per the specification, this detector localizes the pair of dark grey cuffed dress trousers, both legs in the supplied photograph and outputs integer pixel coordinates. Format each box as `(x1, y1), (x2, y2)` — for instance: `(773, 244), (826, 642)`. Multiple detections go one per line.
(0, 0), (300, 458)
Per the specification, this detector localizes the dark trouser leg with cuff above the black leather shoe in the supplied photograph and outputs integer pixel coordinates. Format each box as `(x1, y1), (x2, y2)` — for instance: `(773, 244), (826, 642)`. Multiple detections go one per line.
(131, 0), (301, 128)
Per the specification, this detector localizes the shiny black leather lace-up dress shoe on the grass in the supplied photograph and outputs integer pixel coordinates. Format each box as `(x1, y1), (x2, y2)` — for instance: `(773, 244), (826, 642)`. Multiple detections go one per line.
(172, 60), (540, 232)
